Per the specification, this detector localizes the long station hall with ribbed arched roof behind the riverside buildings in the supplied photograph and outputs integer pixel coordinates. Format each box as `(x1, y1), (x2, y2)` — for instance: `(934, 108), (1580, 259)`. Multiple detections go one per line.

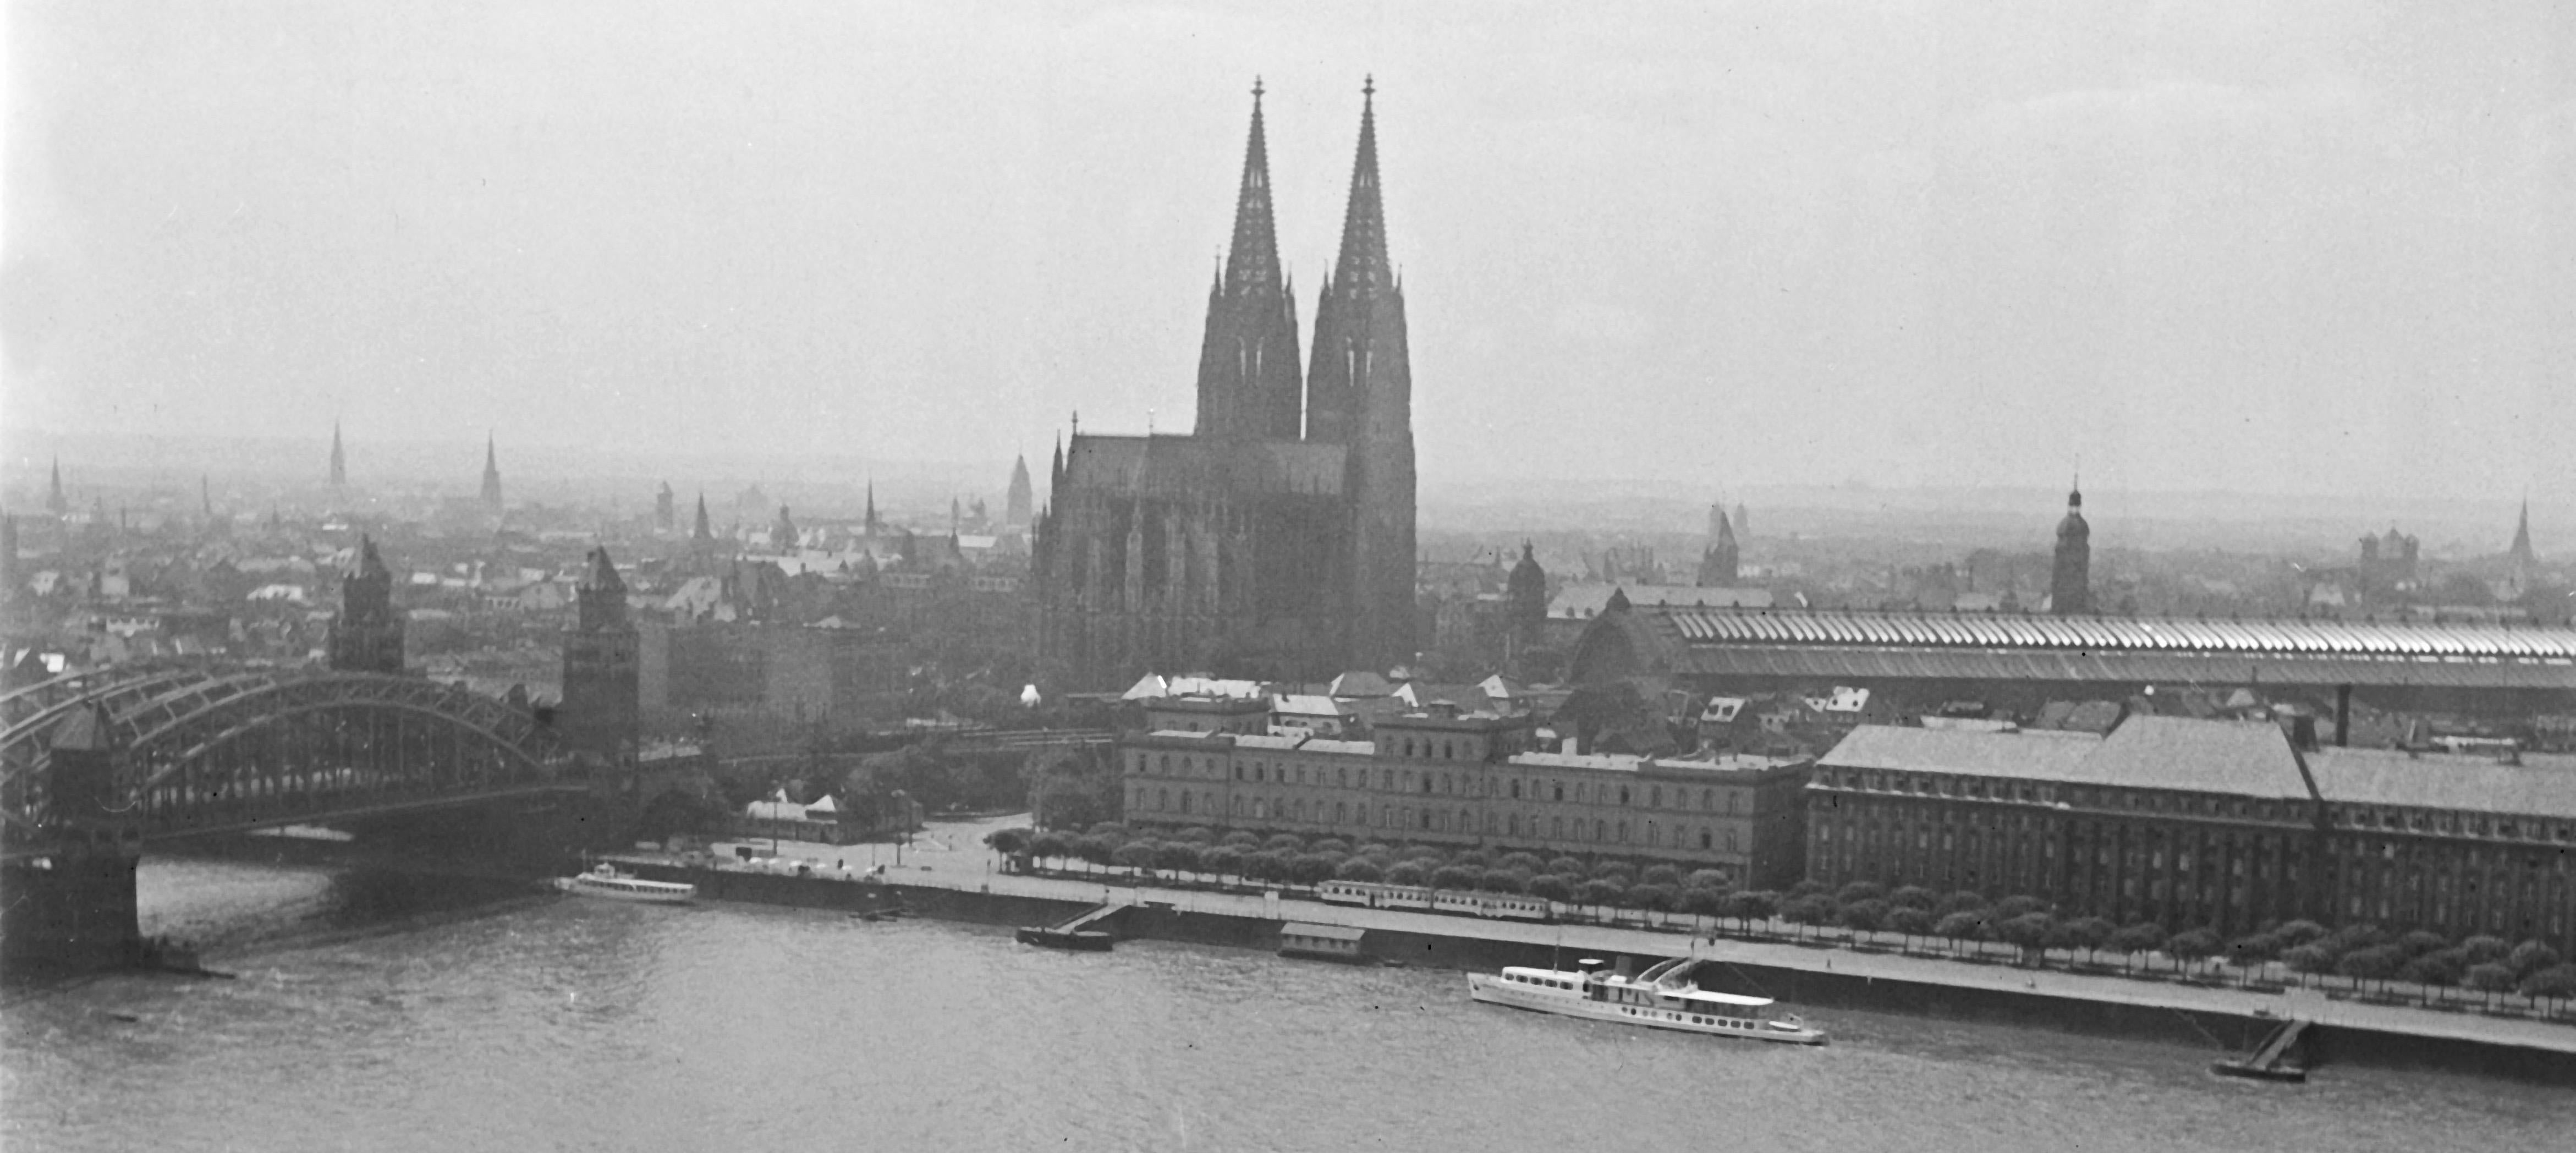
(1572, 605), (2576, 726)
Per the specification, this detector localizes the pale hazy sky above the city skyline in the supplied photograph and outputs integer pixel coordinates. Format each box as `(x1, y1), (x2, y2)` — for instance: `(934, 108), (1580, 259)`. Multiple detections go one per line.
(0, 0), (2576, 502)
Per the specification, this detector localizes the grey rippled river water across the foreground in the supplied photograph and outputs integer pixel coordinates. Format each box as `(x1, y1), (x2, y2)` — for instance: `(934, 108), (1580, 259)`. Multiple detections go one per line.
(0, 860), (2576, 1153)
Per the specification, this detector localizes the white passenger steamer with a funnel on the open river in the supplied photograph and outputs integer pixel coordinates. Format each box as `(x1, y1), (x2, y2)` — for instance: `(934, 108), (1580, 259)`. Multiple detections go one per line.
(1466, 957), (1824, 1045)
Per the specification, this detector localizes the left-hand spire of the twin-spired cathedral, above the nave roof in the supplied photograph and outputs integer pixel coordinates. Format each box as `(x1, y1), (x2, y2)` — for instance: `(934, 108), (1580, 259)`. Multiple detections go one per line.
(1198, 80), (1301, 440)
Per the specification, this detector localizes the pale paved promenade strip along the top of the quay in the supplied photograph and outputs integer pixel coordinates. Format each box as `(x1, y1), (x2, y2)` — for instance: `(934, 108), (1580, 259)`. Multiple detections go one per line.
(631, 821), (2576, 1058)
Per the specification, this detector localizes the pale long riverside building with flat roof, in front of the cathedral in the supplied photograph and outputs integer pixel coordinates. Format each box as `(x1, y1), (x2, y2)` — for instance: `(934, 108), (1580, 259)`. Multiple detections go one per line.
(1118, 702), (1808, 888)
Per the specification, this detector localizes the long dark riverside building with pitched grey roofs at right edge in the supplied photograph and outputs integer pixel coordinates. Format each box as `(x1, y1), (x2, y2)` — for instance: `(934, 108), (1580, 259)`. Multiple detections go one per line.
(1806, 716), (2576, 947)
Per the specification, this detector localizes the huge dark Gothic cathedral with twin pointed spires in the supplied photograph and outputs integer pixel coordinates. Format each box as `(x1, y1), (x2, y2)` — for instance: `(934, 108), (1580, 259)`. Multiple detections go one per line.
(1033, 85), (1417, 687)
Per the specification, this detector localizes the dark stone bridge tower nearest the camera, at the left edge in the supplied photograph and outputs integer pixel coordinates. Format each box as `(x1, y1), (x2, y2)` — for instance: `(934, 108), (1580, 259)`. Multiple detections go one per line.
(0, 702), (142, 970)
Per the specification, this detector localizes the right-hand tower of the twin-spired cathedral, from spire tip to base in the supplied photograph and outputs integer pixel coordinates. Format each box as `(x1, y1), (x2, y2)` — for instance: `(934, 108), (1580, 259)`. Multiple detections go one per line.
(1306, 80), (1417, 669)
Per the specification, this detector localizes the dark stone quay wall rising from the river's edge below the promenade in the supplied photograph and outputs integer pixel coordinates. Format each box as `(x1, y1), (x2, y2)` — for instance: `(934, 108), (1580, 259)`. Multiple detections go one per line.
(621, 857), (2576, 1086)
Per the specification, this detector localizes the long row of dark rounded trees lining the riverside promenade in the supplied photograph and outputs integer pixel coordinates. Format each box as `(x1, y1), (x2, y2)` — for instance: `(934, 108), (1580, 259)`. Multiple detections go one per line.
(987, 823), (2576, 1024)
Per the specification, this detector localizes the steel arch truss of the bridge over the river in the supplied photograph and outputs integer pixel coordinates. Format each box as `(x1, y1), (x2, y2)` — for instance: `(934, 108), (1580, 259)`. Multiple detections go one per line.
(0, 664), (587, 860)
